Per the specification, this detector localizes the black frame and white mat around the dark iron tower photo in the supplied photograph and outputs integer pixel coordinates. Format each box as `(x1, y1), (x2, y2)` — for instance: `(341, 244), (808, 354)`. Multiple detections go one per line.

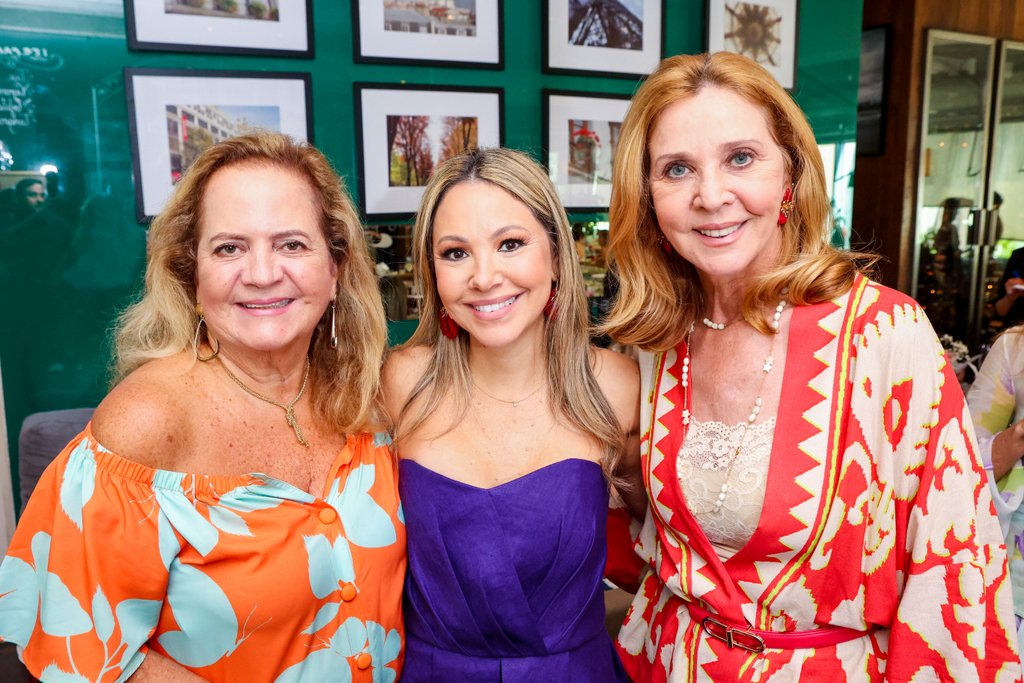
(541, 0), (666, 80)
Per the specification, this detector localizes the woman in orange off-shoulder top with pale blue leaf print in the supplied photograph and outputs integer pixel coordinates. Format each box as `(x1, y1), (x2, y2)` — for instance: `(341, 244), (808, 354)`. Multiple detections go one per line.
(0, 133), (406, 683)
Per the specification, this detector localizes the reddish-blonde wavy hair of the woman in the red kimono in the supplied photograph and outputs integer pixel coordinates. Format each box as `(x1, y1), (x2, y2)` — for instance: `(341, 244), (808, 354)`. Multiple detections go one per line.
(600, 52), (876, 351)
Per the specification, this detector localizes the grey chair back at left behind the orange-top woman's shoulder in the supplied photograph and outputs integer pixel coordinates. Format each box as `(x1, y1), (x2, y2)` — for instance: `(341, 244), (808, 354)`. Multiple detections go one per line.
(17, 408), (95, 510)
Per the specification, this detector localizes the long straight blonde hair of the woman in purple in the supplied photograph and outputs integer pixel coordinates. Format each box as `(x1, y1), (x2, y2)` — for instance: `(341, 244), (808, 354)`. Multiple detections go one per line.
(395, 148), (625, 480)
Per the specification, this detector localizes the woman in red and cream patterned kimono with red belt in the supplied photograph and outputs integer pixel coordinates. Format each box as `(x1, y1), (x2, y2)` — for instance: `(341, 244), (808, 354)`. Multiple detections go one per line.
(606, 52), (1021, 683)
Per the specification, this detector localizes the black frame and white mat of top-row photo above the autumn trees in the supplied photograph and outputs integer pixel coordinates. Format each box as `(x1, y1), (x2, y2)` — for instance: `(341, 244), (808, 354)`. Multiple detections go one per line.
(350, 0), (505, 71)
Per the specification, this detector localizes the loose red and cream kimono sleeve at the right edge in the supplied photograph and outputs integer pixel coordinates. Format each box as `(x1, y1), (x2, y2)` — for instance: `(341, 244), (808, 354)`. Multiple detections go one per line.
(850, 293), (1021, 681)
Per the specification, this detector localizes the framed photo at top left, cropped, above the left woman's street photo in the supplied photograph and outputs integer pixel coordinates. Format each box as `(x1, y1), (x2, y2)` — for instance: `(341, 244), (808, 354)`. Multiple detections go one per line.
(125, 0), (313, 57)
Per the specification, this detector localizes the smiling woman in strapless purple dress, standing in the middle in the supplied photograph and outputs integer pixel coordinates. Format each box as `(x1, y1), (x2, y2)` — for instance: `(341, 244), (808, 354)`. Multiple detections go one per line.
(384, 150), (644, 683)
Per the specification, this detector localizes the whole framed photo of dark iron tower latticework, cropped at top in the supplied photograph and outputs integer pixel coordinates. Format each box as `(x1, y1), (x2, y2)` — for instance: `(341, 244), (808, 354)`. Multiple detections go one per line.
(541, 0), (665, 79)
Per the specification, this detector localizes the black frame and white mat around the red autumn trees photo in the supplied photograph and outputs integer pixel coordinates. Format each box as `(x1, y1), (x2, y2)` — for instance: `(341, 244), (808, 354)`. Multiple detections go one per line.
(352, 82), (505, 221)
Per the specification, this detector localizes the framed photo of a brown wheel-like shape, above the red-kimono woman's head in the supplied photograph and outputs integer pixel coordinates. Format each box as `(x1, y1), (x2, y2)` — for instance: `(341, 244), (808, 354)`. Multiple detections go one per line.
(708, 0), (800, 90)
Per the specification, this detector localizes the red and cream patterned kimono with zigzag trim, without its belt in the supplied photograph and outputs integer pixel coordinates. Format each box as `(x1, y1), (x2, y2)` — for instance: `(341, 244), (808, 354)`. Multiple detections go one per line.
(618, 278), (1021, 683)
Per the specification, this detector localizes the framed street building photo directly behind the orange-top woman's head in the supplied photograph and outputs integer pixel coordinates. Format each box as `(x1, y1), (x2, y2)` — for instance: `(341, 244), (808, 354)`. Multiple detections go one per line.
(125, 69), (313, 222)
